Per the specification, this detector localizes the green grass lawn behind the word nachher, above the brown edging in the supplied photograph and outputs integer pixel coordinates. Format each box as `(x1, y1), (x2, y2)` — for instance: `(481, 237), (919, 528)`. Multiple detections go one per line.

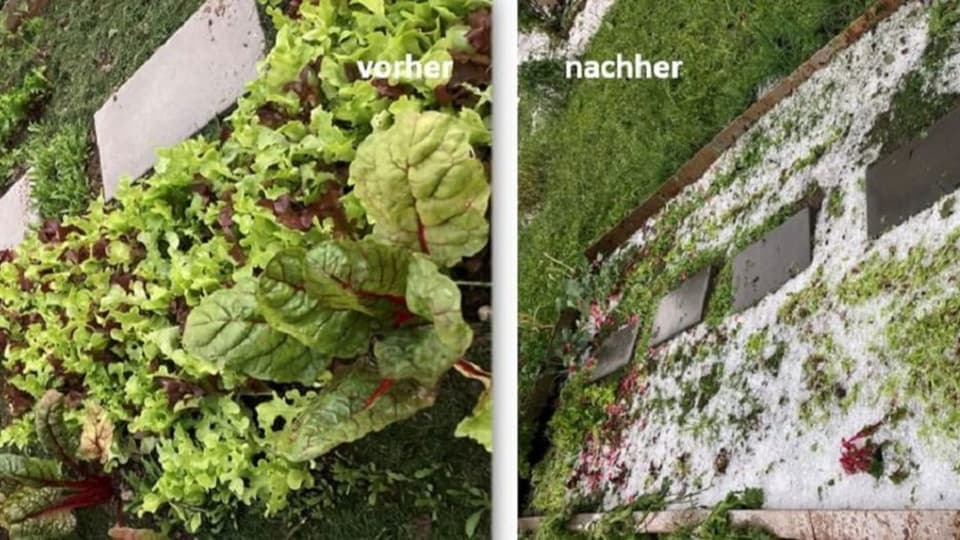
(519, 0), (870, 414)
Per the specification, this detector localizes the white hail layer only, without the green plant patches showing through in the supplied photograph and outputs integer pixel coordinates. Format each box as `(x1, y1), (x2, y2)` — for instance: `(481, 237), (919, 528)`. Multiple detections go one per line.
(581, 4), (960, 508)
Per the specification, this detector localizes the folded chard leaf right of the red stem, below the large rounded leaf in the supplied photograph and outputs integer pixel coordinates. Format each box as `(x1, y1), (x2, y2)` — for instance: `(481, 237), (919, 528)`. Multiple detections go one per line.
(374, 256), (473, 387)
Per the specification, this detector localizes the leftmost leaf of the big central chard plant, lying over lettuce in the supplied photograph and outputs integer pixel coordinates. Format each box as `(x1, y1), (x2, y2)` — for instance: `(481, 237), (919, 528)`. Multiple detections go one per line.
(183, 280), (330, 384)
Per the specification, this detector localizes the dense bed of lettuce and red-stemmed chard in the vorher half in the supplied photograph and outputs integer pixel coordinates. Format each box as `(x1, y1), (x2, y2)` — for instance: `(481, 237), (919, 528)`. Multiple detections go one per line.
(0, 0), (492, 539)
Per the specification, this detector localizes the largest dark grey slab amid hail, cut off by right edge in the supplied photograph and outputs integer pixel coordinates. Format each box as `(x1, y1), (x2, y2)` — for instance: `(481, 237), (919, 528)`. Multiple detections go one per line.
(867, 107), (960, 238)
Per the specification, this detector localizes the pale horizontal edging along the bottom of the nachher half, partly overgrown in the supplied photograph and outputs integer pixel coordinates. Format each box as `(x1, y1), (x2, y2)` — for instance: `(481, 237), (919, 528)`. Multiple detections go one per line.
(519, 509), (960, 540)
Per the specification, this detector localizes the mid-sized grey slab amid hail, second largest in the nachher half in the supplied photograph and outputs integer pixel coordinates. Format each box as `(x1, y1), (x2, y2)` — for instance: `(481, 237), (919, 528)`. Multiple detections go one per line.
(733, 207), (813, 311)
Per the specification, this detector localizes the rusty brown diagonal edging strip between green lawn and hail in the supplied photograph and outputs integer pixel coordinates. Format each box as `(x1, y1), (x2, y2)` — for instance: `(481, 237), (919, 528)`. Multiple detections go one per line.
(585, 0), (911, 261)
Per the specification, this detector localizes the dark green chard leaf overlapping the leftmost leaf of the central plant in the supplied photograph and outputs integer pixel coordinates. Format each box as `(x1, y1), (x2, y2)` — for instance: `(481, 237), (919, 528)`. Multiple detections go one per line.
(257, 250), (373, 358)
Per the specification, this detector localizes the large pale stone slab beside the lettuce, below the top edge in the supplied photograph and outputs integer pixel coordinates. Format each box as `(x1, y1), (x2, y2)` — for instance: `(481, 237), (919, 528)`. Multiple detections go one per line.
(94, 0), (265, 199)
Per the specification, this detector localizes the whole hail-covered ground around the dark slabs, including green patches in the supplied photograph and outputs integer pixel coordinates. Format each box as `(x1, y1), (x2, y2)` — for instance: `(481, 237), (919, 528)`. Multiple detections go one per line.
(573, 3), (960, 509)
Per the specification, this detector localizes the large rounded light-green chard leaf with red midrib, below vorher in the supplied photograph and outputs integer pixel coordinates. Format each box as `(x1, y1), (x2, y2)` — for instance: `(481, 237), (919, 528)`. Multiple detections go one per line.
(350, 111), (490, 266)
